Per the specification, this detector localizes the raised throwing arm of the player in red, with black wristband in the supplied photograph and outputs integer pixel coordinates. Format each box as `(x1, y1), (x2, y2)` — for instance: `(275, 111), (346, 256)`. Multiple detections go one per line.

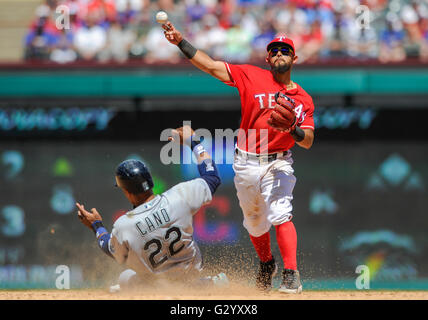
(162, 21), (232, 82)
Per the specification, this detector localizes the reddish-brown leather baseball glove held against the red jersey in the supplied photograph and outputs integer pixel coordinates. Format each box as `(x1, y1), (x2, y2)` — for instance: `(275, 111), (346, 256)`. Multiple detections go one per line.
(267, 92), (297, 132)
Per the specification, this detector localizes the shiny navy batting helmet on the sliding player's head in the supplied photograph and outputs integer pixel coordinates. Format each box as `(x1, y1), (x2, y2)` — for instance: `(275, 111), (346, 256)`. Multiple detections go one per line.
(116, 159), (154, 194)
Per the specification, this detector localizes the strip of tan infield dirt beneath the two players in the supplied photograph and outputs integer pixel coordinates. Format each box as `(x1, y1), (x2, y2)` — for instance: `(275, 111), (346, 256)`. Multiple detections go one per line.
(0, 286), (428, 300)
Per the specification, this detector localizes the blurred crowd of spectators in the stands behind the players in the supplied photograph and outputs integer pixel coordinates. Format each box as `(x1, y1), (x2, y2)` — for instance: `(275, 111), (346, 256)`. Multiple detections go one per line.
(24, 0), (428, 63)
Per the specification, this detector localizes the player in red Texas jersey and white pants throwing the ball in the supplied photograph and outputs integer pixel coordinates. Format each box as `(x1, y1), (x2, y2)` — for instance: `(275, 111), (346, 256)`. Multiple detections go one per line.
(162, 21), (314, 293)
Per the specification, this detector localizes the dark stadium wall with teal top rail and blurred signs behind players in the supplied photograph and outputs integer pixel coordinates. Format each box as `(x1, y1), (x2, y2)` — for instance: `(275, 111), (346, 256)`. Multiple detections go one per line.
(0, 68), (428, 290)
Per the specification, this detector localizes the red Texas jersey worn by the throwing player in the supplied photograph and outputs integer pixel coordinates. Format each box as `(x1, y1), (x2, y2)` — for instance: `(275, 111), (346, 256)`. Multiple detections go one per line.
(225, 63), (315, 154)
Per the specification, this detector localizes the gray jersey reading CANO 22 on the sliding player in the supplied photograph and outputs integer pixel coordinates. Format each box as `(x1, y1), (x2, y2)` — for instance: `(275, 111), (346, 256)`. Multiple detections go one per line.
(109, 178), (212, 280)
